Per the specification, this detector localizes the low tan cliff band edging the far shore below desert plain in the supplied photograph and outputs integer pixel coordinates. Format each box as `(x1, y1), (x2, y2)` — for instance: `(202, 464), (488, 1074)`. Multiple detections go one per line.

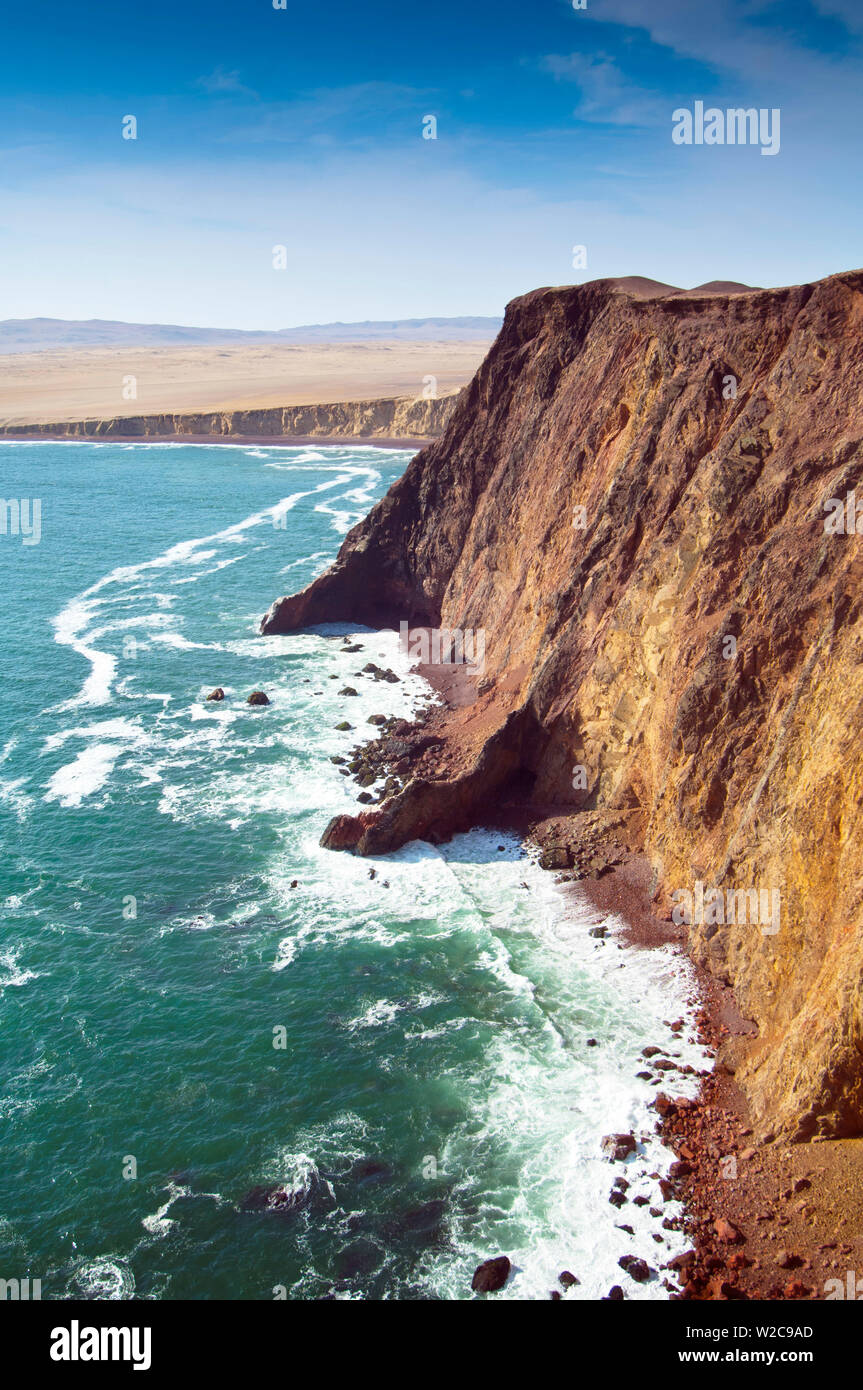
(0, 395), (457, 439)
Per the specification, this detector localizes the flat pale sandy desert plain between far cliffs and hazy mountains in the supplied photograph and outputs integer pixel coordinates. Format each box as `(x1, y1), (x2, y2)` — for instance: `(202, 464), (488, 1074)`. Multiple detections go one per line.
(0, 342), (488, 425)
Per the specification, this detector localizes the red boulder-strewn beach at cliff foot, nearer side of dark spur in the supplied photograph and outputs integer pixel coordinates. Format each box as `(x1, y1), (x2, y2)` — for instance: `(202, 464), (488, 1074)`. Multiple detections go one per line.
(539, 839), (863, 1301)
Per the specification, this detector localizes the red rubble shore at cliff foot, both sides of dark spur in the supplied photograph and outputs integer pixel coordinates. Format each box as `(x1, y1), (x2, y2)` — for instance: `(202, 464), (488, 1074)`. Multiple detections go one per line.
(334, 653), (863, 1301)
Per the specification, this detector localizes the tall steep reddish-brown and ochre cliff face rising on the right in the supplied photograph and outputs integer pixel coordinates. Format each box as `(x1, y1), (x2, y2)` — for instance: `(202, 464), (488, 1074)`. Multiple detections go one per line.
(263, 271), (863, 1138)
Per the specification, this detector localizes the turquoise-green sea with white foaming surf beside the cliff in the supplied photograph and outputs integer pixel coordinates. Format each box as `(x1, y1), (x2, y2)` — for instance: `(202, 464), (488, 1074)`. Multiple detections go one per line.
(0, 443), (700, 1300)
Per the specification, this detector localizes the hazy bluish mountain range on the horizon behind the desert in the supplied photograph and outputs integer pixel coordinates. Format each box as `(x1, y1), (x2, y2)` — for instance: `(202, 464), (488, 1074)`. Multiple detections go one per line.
(0, 317), (503, 353)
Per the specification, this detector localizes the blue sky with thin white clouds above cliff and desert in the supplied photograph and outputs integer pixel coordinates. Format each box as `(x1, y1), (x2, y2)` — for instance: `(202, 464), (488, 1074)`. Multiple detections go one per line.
(0, 0), (863, 328)
